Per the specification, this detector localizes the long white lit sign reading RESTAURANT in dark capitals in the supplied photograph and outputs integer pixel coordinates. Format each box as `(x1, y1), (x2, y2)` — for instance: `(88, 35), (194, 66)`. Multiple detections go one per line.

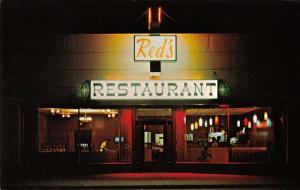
(90, 80), (218, 100)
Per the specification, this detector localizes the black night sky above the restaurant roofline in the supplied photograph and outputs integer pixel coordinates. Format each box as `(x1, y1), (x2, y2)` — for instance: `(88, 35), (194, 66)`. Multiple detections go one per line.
(2, 0), (300, 33)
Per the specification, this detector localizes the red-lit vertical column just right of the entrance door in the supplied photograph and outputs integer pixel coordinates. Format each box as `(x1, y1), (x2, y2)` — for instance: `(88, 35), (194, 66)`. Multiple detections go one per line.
(174, 109), (187, 162)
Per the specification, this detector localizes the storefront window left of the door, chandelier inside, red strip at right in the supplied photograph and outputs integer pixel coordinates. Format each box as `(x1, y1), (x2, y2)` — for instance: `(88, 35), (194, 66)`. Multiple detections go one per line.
(38, 108), (132, 163)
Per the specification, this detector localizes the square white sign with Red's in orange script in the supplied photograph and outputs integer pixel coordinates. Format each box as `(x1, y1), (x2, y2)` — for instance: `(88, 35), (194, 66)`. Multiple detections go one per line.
(134, 35), (177, 61)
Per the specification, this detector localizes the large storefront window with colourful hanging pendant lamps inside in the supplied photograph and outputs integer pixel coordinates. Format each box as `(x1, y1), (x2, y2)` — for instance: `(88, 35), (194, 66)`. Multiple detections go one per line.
(181, 108), (274, 163)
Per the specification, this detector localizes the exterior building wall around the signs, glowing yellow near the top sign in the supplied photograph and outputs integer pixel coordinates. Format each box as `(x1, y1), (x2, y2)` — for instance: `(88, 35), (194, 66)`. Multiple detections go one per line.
(2, 34), (285, 167)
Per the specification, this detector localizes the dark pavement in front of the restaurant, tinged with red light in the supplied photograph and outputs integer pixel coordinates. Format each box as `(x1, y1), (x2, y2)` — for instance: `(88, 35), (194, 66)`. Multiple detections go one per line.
(2, 172), (300, 189)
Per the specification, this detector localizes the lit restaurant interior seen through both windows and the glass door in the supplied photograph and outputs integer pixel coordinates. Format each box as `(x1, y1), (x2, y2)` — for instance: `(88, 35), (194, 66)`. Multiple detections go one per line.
(38, 107), (274, 163)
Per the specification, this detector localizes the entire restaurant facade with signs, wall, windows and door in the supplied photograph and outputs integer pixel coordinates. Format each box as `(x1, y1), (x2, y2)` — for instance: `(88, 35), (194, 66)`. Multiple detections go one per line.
(2, 33), (288, 174)
